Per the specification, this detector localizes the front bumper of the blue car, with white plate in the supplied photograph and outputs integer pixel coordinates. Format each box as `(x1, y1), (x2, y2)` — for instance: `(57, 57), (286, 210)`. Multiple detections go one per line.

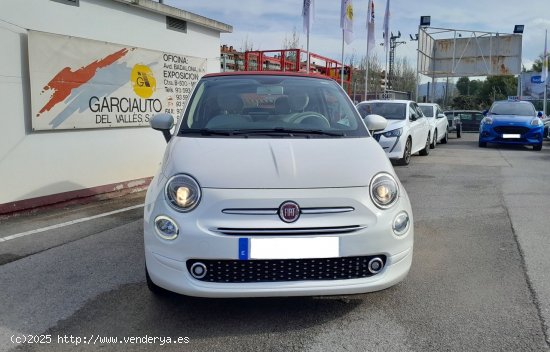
(479, 124), (544, 145)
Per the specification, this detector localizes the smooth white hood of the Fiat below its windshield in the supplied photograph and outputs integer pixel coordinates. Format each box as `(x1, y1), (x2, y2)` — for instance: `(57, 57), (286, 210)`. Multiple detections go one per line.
(162, 137), (395, 188)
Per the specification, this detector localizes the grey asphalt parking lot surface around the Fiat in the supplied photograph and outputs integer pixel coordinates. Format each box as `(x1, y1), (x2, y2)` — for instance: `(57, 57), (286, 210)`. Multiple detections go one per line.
(0, 134), (550, 351)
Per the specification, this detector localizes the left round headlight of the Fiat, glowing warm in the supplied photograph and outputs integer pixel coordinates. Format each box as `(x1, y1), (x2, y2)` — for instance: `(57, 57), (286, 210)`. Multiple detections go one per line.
(165, 174), (201, 213)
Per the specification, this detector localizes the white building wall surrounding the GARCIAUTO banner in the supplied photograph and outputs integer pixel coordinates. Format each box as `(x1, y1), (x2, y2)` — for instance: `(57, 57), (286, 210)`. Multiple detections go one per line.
(0, 0), (224, 205)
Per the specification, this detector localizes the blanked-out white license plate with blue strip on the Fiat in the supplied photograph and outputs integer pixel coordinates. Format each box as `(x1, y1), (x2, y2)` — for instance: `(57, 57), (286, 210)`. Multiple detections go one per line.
(245, 237), (340, 259)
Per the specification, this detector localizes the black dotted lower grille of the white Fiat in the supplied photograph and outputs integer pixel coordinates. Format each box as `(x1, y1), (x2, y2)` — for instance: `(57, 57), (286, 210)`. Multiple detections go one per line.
(187, 255), (386, 283)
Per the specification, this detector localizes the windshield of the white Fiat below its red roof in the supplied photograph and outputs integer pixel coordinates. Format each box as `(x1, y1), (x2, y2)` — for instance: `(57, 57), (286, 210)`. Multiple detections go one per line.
(178, 74), (369, 138)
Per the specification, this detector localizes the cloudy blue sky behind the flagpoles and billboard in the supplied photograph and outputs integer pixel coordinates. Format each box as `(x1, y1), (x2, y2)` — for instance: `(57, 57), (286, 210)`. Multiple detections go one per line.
(164, 0), (550, 79)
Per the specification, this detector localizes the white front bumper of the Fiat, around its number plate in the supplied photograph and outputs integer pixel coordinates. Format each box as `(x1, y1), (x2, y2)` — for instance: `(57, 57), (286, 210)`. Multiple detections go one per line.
(144, 186), (414, 297)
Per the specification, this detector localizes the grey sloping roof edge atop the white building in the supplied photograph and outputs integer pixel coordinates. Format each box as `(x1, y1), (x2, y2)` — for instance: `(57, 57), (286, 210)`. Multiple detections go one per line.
(114, 0), (233, 33)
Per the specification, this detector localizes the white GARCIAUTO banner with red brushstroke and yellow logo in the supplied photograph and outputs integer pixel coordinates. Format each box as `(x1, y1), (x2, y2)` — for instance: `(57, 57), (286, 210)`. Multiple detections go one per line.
(29, 31), (206, 130)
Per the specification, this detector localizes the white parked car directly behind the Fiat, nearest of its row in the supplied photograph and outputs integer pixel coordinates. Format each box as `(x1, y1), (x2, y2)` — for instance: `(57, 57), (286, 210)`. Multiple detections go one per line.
(357, 100), (432, 165)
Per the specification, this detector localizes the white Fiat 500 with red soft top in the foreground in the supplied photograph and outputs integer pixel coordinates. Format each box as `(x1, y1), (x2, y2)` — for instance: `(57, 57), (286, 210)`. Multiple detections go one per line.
(144, 72), (414, 297)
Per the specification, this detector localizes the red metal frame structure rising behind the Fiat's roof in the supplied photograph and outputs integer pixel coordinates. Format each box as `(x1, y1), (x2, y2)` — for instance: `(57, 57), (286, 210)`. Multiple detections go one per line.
(244, 49), (352, 94)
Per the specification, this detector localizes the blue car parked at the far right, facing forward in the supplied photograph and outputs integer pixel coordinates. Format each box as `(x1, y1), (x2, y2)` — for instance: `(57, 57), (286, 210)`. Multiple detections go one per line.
(479, 101), (544, 150)
